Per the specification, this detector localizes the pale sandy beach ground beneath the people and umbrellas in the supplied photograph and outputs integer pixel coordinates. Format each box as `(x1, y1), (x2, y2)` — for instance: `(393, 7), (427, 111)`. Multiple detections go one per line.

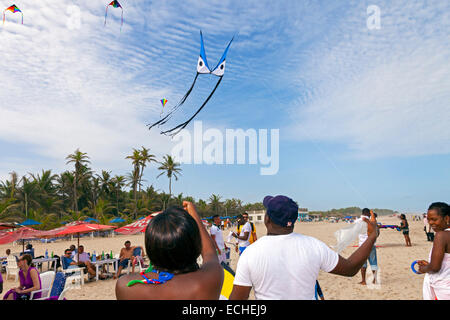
(0, 216), (432, 300)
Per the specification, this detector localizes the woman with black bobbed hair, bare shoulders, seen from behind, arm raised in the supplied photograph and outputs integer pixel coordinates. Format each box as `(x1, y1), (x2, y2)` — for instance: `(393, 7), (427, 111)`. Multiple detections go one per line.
(116, 201), (224, 300)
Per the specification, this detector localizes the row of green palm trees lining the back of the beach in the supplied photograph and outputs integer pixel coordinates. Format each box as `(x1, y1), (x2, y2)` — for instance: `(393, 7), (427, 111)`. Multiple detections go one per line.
(0, 147), (264, 225)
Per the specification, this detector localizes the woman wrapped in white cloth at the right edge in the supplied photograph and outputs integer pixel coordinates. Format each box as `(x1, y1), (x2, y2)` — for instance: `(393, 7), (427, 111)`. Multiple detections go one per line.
(417, 202), (450, 300)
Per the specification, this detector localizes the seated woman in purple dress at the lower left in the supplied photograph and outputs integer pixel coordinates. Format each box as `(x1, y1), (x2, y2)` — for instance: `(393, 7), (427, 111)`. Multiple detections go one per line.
(3, 254), (41, 300)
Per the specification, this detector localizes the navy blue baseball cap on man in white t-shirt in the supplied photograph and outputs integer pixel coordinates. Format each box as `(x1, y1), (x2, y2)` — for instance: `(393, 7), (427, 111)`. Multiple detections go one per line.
(263, 196), (298, 227)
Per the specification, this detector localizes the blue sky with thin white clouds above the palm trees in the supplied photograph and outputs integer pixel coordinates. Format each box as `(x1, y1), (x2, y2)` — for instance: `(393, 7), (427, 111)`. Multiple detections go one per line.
(0, 0), (450, 212)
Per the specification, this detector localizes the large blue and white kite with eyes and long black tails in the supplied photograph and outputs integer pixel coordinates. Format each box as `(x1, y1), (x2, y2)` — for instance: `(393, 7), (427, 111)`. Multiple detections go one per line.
(148, 31), (234, 137)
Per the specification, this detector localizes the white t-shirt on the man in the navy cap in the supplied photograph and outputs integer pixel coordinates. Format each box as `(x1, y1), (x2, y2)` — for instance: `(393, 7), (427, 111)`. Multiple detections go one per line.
(234, 233), (339, 300)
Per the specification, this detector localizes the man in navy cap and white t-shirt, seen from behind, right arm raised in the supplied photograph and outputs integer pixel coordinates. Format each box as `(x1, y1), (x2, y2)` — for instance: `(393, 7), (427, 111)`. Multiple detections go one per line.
(230, 196), (377, 300)
